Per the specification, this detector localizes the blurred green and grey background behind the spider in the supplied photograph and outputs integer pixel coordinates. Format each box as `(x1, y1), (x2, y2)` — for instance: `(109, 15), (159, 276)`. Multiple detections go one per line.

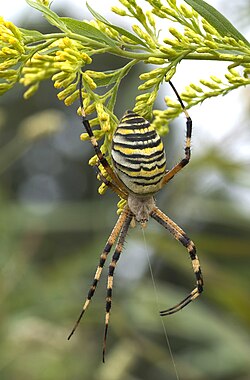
(0, 2), (250, 380)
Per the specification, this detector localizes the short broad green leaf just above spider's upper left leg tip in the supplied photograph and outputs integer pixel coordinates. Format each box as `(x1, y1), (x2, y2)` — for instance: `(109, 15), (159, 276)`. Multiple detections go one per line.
(60, 17), (116, 47)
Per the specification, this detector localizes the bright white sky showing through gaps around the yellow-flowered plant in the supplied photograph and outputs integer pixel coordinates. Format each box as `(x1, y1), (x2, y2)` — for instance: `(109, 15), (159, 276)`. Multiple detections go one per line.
(0, 0), (250, 158)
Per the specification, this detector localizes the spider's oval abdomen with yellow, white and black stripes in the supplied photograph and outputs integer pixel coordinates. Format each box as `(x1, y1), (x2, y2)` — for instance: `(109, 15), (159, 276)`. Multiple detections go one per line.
(112, 111), (166, 195)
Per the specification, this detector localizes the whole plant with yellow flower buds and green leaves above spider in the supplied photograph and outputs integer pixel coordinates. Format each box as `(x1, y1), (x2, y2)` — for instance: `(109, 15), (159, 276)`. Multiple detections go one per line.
(0, 0), (250, 196)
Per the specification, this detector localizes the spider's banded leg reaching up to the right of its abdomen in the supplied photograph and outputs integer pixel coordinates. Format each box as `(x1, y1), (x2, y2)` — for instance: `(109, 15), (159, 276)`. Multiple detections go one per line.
(161, 81), (192, 187)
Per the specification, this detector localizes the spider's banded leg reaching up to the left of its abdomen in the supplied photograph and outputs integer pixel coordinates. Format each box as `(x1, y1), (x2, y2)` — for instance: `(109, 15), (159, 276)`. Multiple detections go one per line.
(79, 74), (127, 193)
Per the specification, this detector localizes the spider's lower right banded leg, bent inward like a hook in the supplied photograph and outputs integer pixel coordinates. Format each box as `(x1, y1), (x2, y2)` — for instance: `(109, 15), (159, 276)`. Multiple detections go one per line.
(150, 207), (203, 316)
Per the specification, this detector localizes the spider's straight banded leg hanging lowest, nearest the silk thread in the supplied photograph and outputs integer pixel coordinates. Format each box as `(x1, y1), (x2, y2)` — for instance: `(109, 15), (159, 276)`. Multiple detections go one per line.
(102, 212), (133, 363)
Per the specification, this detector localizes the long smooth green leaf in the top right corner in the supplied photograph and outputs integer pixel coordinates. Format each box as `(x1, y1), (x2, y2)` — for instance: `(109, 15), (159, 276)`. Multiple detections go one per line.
(184, 0), (249, 45)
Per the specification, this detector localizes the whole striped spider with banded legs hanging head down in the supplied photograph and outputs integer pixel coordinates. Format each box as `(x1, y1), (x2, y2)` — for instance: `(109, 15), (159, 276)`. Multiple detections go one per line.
(68, 77), (203, 362)
